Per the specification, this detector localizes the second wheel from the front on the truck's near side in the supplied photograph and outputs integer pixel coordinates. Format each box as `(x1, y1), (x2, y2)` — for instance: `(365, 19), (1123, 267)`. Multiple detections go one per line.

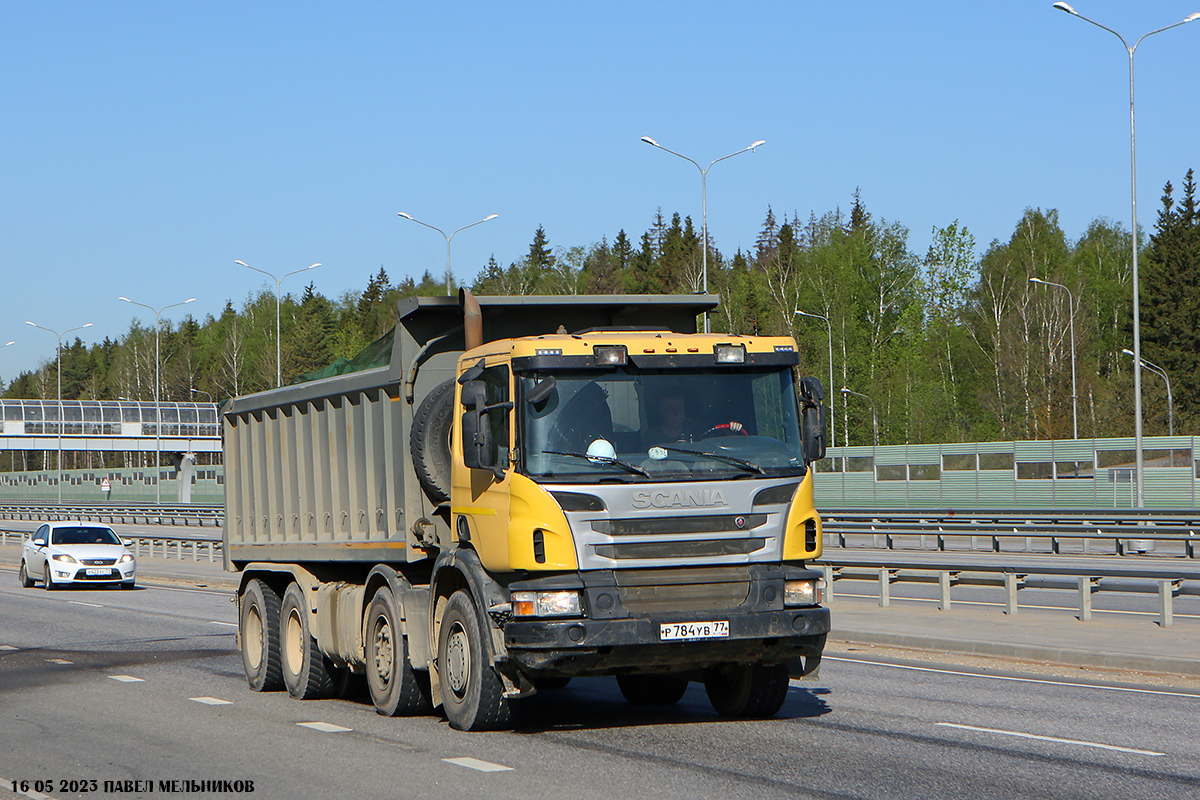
(364, 588), (431, 717)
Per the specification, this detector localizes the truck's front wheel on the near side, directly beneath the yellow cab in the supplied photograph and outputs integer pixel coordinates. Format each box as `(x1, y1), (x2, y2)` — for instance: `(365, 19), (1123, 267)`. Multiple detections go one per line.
(438, 590), (512, 730)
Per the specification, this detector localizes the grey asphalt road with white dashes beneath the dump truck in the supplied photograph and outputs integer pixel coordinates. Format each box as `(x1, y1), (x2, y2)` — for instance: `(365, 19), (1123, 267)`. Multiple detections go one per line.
(0, 573), (1200, 800)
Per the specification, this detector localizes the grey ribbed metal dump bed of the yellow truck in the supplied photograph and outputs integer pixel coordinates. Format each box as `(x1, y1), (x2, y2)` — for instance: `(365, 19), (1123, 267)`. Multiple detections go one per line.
(223, 295), (718, 566)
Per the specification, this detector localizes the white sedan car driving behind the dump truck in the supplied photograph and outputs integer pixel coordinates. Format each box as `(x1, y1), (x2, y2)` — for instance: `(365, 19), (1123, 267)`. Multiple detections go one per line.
(20, 522), (137, 589)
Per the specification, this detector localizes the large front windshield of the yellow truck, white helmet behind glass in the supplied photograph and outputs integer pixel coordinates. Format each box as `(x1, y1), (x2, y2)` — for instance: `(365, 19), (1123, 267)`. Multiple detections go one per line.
(521, 366), (804, 482)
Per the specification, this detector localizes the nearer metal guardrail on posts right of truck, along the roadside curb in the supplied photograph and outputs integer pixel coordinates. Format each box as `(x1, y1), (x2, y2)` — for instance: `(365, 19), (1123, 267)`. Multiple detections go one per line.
(812, 552), (1200, 627)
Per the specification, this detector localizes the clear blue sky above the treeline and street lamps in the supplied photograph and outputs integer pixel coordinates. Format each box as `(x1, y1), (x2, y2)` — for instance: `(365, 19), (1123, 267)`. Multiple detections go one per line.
(0, 0), (1200, 380)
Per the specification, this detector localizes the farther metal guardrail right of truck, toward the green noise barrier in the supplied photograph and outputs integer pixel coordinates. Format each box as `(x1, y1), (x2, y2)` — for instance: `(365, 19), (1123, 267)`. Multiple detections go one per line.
(822, 509), (1200, 559)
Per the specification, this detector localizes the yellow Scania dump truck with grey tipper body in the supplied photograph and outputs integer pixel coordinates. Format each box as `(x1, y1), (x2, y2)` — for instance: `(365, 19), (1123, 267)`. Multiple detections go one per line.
(223, 293), (829, 730)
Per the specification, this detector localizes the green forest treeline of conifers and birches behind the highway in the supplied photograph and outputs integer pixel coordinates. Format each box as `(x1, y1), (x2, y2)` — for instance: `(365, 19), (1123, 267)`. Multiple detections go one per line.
(4, 170), (1200, 444)
